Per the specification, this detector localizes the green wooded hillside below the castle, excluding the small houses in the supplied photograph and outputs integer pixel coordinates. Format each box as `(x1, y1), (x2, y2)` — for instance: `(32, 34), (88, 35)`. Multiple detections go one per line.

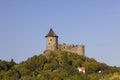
(0, 50), (120, 80)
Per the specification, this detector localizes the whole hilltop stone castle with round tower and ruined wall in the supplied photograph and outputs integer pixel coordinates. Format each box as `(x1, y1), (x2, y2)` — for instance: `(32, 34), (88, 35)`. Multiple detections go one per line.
(45, 28), (85, 56)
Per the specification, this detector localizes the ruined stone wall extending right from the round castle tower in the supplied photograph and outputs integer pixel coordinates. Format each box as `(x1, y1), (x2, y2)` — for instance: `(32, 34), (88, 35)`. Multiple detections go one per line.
(58, 43), (84, 56)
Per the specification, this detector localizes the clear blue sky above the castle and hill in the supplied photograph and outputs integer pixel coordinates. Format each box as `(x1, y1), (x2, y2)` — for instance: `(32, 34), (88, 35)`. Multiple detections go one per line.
(0, 0), (120, 66)
